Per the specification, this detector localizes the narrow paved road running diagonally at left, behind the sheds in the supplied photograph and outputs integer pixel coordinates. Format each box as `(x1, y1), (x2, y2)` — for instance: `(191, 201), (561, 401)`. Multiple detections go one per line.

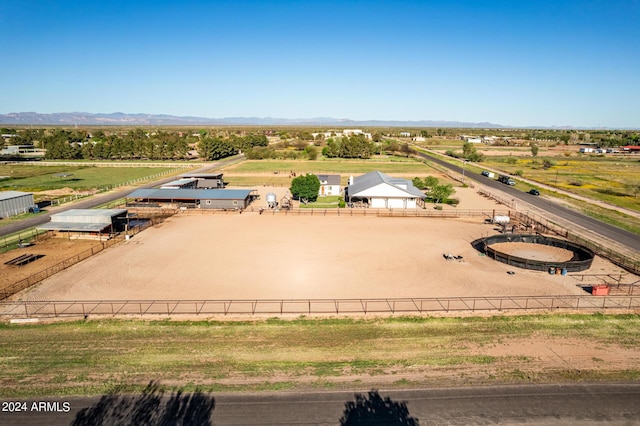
(0, 158), (244, 237)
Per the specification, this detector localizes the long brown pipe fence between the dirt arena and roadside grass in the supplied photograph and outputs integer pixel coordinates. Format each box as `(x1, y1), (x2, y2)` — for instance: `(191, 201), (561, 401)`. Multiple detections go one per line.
(0, 295), (640, 319)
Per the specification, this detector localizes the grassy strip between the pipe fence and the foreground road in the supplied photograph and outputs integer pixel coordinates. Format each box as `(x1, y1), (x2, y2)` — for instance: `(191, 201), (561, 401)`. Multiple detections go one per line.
(0, 314), (640, 398)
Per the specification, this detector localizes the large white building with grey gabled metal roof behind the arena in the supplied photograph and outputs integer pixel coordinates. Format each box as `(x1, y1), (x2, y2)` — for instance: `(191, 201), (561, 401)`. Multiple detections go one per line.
(345, 171), (426, 209)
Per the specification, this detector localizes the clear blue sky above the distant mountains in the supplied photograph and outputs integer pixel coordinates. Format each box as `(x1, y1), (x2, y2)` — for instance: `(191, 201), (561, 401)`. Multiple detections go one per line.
(0, 0), (640, 128)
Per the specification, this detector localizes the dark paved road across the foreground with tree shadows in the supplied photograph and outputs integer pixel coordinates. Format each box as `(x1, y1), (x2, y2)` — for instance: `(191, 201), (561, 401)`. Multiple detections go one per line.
(0, 384), (640, 425)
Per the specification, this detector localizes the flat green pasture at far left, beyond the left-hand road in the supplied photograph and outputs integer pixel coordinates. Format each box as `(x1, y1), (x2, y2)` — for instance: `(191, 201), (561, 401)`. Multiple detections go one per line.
(0, 165), (176, 192)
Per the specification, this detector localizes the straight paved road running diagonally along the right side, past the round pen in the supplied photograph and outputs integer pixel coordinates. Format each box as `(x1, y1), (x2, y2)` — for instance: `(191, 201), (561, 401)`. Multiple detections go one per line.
(418, 153), (640, 252)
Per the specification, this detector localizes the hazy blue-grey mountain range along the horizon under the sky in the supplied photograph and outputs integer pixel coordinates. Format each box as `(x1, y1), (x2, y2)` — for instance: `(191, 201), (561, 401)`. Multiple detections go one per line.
(0, 112), (505, 128)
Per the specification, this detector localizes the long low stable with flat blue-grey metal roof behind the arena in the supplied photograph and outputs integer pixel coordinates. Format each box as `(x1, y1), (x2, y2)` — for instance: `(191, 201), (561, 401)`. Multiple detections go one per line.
(126, 188), (256, 210)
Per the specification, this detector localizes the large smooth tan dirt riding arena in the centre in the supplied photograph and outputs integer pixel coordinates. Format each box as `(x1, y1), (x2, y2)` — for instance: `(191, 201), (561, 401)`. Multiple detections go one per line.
(6, 187), (624, 300)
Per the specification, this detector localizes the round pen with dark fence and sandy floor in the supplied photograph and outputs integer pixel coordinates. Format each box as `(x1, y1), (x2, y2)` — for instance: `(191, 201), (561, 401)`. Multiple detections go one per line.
(472, 234), (594, 272)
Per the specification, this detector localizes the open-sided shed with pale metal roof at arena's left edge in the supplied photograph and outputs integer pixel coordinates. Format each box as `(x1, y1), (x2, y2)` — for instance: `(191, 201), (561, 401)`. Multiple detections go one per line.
(37, 209), (129, 239)
